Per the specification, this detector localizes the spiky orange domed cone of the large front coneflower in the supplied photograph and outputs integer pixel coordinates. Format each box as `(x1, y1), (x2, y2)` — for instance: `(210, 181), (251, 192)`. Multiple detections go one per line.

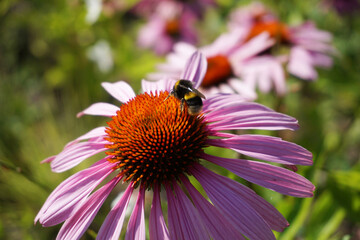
(105, 92), (208, 188)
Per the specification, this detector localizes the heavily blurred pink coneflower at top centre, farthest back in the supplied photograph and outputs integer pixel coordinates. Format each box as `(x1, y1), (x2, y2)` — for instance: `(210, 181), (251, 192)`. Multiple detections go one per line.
(138, 1), (197, 55)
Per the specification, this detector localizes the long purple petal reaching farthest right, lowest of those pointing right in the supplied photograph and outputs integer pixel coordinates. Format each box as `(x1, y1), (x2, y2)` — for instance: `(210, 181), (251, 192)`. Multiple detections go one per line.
(203, 155), (315, 197)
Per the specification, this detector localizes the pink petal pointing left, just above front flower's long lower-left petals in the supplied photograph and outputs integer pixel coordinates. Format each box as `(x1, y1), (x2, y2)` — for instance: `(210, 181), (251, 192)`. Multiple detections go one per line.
(51, 137), (107, 172)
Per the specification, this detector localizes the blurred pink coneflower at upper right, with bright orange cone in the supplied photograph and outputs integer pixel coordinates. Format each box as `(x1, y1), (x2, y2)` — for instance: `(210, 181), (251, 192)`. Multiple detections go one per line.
(229, 3), (335, 83)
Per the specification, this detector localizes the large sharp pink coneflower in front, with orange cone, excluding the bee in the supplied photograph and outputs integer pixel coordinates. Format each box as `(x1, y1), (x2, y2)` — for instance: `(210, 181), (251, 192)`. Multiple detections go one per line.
(35, 53), (314, 240)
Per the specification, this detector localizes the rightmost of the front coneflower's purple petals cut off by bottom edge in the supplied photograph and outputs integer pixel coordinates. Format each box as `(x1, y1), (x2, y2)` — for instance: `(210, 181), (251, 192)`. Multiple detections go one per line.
(191, 164), (275, 240)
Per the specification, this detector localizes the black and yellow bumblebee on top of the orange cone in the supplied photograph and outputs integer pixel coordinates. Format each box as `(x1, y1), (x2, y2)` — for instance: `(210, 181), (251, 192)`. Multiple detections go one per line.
(166, 79), (205, 115)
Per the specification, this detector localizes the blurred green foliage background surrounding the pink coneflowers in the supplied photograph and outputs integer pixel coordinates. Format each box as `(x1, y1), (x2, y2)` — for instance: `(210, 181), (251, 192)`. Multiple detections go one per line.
(0, 0), (360, 239)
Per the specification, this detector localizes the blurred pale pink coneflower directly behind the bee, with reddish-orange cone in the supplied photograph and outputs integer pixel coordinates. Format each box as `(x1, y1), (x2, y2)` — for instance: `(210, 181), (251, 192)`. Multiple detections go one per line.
(148, 29), (278, 98)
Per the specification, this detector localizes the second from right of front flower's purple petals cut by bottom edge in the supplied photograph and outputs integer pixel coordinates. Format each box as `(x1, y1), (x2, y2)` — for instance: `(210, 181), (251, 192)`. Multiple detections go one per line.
(181, 176), (245, 240)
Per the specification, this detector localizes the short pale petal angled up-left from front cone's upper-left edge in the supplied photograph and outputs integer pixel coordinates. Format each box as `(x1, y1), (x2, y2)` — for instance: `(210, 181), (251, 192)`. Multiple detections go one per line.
(101, 81), (136, 103)
